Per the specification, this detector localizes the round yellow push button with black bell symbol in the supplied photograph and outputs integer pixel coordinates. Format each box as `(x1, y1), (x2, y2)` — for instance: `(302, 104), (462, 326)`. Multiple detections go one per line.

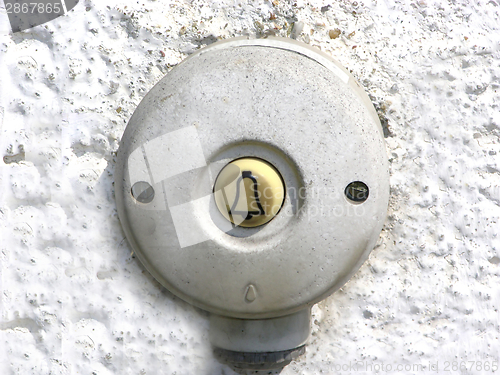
(214, 158), (285, 228)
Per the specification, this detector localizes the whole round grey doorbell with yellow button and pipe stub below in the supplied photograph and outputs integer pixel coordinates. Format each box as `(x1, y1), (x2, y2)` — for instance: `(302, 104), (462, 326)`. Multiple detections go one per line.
(115, 38), (389, 369)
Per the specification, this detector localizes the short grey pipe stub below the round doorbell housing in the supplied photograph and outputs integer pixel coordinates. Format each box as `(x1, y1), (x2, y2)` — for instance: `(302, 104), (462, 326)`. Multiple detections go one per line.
(210, 308), (311, 369)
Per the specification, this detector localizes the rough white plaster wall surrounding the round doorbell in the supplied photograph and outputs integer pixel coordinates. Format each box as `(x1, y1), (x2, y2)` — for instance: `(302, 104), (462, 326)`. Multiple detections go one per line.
(0, 0), (500, 375)
